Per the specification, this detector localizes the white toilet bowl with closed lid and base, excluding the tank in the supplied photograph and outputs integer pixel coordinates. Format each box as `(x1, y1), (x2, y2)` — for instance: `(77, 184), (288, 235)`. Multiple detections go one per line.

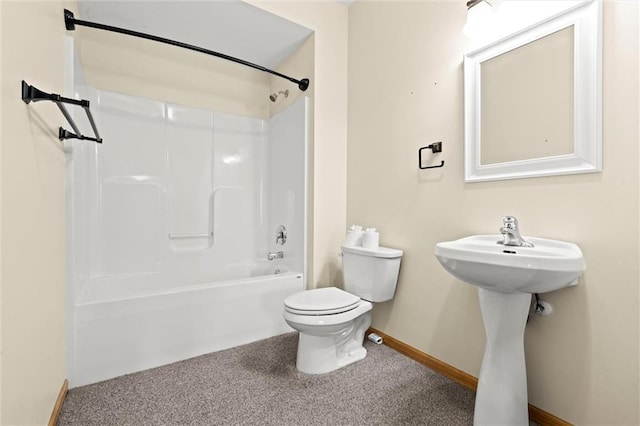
(284, 287), (372, 374)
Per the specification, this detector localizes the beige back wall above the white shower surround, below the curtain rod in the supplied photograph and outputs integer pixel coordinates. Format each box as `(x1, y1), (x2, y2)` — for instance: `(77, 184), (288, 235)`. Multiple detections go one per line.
(73, 27), (270, 118)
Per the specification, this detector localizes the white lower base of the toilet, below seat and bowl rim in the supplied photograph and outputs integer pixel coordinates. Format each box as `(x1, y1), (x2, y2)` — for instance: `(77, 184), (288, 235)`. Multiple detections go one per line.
(296, 312), (371, 374)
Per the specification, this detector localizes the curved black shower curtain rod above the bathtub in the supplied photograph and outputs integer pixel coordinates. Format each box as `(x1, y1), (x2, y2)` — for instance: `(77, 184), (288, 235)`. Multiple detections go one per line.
(64, 9), (309, 92)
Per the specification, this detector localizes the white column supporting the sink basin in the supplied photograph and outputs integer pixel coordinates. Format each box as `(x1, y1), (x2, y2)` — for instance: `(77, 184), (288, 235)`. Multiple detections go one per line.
(473, 288), (531, 426)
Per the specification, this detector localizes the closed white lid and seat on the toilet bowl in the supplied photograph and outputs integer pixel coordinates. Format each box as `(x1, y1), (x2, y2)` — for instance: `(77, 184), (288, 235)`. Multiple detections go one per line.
(284, 287), (360, 315)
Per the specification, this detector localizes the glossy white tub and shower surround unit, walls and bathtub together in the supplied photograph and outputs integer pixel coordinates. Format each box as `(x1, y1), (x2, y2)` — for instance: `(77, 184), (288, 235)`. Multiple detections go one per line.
(65, 42), (307, 387)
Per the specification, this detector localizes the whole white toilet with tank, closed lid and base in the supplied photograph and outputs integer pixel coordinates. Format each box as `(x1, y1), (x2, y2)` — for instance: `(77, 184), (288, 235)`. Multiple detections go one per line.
(284, 246), (402, 374)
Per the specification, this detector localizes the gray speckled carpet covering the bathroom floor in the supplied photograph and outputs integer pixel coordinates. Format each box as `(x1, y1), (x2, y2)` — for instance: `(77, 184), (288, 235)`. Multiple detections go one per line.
(59, 333), (475, 426)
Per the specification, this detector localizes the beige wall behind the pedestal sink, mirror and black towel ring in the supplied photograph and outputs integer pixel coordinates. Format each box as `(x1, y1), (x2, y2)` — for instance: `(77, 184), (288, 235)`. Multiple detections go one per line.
(347, 1), (640, 425)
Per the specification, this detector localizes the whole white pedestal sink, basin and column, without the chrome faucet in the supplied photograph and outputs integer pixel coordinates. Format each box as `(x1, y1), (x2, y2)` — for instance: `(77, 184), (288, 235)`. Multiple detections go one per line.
(435, 235), (584, 426)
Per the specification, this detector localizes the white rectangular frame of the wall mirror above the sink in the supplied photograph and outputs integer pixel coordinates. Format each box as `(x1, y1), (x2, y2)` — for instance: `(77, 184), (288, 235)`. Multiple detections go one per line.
(464, 1), (602, 182)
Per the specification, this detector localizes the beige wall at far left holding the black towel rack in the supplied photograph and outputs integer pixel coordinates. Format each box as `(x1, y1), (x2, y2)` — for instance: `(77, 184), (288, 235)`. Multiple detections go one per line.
(0, 0), (69, 425)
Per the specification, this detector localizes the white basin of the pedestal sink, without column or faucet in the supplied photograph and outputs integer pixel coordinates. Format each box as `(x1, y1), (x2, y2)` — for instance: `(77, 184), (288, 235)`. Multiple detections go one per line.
(435, 235), (584, 293)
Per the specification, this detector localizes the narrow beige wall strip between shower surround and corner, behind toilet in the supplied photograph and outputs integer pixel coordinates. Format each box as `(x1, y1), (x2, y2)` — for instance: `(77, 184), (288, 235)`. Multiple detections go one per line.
(249, 0), (349, 287)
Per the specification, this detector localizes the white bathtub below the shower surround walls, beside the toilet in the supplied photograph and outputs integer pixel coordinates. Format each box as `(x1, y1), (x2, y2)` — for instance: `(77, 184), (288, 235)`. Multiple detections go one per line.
(69, 268), (304, 387)
